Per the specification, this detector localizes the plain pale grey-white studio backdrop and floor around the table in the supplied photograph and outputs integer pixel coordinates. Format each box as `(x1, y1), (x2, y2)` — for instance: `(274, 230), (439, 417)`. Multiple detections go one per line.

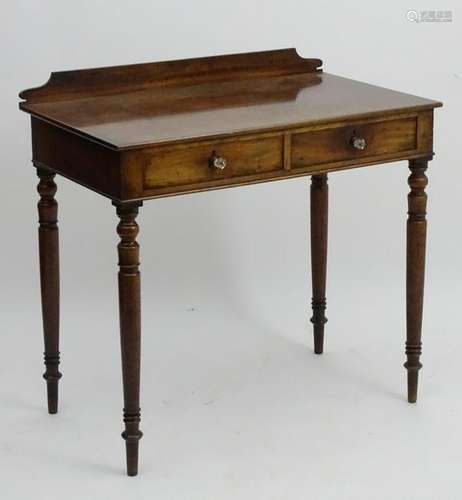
(0, 0), (462, 500)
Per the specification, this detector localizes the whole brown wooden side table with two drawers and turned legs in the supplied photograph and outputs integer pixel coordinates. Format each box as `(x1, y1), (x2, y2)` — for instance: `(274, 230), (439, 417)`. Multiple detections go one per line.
(19, 49), (441, 476)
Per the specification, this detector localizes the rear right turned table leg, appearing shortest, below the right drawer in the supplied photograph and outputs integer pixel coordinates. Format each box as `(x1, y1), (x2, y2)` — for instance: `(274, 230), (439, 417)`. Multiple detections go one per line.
(311, 174), (329, 354)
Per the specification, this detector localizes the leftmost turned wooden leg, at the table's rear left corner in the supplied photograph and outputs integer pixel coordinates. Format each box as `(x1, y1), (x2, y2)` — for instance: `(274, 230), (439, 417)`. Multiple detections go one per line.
(37, 167), (61, 413)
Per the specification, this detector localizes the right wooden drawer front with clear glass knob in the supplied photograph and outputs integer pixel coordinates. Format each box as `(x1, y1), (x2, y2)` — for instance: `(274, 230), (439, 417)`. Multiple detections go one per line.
(291, 117), (417, 168)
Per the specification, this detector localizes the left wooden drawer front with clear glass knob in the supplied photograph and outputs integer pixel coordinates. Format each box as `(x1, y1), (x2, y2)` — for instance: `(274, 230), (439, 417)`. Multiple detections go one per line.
(143, 135), (283, 189)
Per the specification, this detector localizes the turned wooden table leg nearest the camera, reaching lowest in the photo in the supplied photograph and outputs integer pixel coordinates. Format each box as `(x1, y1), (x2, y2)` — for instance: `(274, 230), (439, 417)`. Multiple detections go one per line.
(114, 202), (142, 476)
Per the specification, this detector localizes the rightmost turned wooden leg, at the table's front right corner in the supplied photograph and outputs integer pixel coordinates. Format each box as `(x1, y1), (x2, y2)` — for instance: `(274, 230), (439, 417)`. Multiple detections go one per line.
(404, 160), (427, 403)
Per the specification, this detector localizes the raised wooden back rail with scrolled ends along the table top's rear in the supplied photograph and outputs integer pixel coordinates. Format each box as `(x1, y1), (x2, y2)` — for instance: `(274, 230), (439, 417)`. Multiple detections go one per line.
(19, 48), (322, 102)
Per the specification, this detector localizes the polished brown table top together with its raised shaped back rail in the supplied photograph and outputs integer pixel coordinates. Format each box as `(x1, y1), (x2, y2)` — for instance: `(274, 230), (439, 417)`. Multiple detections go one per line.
(20, 49), (441, 149)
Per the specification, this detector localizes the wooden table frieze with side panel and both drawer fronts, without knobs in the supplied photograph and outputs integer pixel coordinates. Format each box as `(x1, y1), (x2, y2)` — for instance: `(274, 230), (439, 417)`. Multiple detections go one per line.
(28, 110), (433, 201)
